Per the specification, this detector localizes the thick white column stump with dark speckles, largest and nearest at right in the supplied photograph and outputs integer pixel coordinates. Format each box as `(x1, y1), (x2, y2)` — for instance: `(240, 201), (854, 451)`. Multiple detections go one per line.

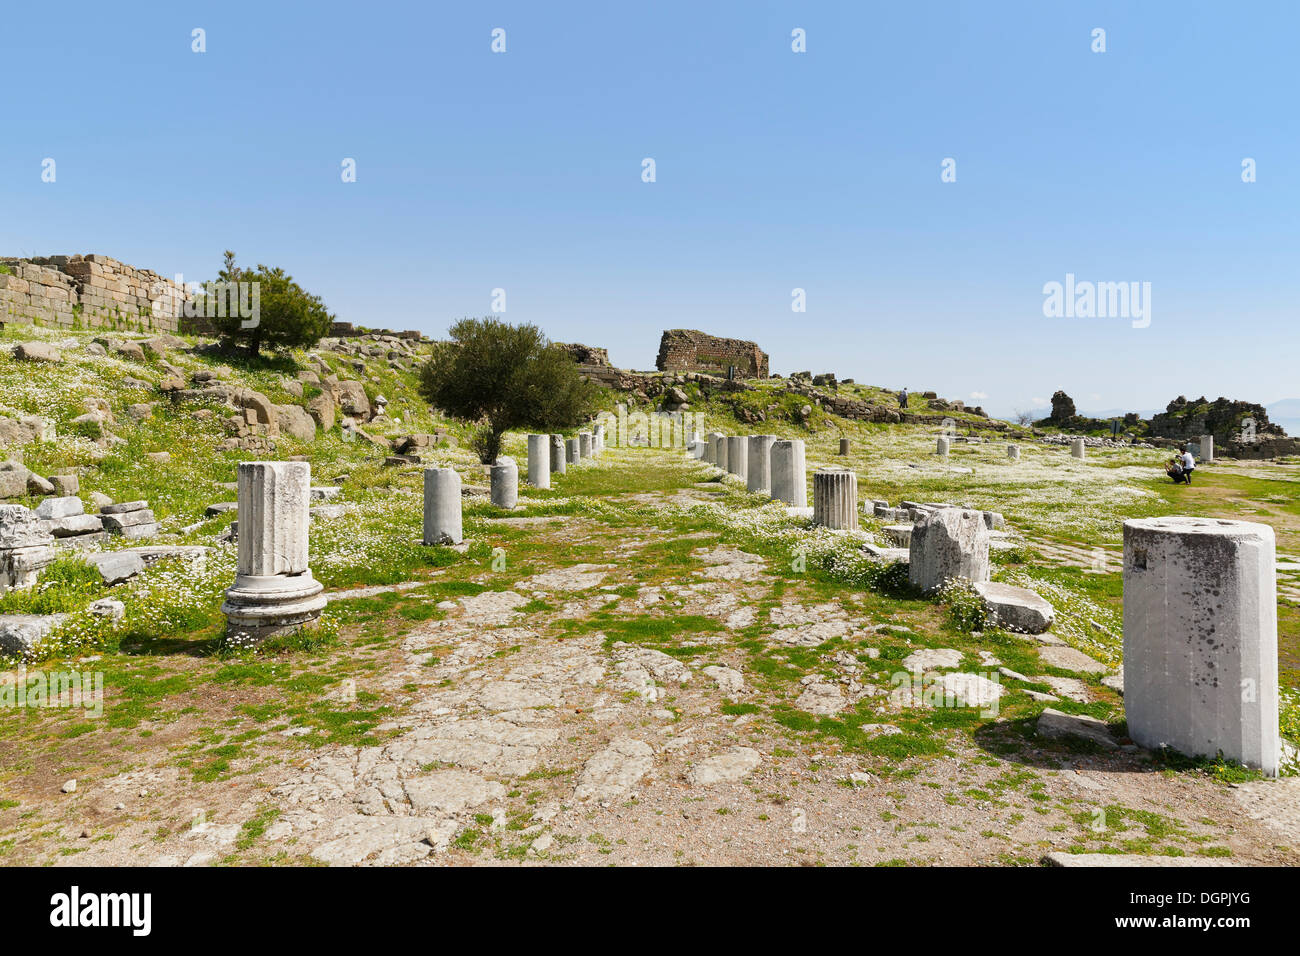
(1125, 516), (1281, 777)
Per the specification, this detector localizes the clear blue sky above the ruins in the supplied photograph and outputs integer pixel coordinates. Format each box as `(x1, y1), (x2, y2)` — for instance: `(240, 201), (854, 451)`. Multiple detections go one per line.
(0, 0), (1300, 414)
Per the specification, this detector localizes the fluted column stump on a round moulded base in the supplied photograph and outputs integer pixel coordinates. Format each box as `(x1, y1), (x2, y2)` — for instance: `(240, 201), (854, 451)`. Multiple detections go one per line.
(221, 462), (325, 641)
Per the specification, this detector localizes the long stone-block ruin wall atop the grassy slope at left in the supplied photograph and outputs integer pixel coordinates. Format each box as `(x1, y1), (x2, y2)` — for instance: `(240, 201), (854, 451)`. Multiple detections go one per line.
(0, 255), (187, 332)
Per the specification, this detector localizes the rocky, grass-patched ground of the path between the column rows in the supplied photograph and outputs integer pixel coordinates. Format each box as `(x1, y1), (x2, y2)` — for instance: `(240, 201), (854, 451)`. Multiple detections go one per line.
(0, 450), (1300, 866)
